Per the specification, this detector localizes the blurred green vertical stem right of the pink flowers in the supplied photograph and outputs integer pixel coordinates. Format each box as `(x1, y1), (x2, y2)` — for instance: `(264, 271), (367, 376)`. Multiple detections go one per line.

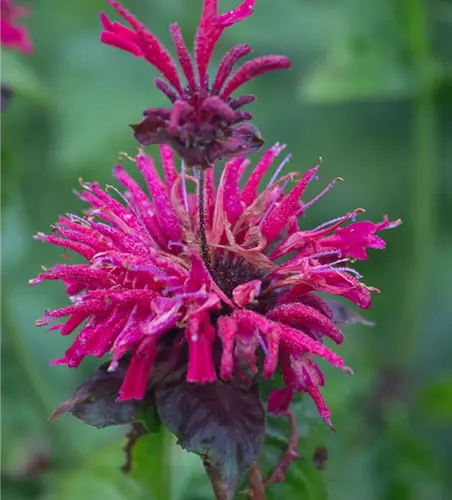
(394, 0), (439, 368)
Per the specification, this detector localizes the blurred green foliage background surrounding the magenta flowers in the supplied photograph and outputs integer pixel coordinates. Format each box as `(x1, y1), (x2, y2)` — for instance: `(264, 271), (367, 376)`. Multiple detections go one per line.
(0, 0), (452, 500)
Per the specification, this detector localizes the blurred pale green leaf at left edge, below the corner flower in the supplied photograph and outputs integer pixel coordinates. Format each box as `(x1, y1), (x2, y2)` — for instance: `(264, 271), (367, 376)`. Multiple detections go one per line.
(0, 49), (53, 106)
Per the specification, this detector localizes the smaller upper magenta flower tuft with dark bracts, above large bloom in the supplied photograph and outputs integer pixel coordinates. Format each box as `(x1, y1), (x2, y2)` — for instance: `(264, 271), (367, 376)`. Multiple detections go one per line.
(101, 0), (291, 168)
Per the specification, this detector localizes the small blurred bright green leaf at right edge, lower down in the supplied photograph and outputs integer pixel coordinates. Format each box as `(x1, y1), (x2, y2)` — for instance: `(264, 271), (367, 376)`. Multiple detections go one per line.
(418, 373), (452, 421)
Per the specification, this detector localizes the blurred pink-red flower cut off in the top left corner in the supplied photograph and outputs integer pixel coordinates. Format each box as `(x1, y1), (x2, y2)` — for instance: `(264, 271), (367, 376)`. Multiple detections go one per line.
(0, 0), (33, 53)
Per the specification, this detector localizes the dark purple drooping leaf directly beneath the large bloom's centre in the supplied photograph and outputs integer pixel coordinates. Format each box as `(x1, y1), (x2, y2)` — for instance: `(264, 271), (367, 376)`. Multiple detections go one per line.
(156, 381), (265, 498)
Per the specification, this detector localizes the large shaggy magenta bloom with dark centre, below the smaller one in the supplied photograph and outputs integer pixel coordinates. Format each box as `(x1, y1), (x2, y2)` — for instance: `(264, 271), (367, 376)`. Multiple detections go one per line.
(31, 145), (400, 423)
